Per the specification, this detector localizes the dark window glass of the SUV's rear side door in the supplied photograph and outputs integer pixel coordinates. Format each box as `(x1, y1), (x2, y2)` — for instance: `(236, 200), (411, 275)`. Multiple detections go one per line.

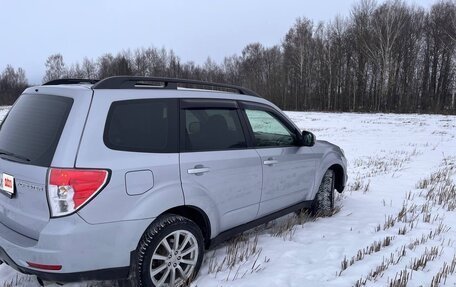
(183, 108), (247, 151)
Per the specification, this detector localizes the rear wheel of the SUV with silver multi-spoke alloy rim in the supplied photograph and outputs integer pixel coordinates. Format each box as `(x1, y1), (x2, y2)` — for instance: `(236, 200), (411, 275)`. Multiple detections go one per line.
(130, 214), (204, 287)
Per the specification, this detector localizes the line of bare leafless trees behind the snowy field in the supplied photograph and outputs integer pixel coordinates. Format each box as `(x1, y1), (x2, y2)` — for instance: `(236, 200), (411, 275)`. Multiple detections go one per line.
(0, 0), (456, 114)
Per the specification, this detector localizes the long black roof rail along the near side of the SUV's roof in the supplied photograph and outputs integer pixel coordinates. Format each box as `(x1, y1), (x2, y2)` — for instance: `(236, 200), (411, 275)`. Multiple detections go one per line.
(92, 76), (258, 97)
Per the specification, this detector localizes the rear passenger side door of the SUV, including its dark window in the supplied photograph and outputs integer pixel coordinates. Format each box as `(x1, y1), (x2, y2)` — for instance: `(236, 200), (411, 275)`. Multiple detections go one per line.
(180, 99), (262, 231)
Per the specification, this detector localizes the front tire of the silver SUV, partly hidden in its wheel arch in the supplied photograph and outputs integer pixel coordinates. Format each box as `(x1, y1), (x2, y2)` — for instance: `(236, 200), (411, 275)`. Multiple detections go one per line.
(310, 169), (334, 216)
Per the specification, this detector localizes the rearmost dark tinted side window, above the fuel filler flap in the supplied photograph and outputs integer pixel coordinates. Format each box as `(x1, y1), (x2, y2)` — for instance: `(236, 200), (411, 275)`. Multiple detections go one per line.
(105, 99), (178, 153)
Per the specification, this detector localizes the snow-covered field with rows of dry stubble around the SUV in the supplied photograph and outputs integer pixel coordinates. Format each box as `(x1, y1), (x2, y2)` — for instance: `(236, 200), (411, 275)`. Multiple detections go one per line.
(0, 111), (456, 287)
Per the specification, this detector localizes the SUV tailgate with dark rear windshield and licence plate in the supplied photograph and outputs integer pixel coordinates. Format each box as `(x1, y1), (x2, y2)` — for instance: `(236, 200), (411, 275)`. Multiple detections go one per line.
(0, 95), (77, 239)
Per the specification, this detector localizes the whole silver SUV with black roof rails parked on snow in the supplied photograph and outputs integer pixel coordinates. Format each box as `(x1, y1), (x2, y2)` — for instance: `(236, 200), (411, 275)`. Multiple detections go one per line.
(0, 77), (347, 286)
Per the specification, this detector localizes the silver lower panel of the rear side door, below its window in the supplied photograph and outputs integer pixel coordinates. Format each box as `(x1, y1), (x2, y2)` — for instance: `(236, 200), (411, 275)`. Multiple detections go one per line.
(180, 149), (262, 235)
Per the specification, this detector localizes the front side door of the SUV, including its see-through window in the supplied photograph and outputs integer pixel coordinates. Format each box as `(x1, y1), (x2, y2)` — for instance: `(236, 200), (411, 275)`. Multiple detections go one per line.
(243, 103), (316, 217)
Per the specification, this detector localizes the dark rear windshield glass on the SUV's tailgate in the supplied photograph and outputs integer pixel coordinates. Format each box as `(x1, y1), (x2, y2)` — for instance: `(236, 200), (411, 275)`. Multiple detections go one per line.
(0, 95), (73, 167)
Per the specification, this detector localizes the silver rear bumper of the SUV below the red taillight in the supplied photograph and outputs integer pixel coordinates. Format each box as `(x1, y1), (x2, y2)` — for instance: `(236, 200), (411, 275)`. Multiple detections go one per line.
(0, 214), (152, 283)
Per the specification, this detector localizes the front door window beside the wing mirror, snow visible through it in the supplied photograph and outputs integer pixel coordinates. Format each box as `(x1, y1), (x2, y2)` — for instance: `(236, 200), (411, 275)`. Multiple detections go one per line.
(245, 109), (295, 147)
